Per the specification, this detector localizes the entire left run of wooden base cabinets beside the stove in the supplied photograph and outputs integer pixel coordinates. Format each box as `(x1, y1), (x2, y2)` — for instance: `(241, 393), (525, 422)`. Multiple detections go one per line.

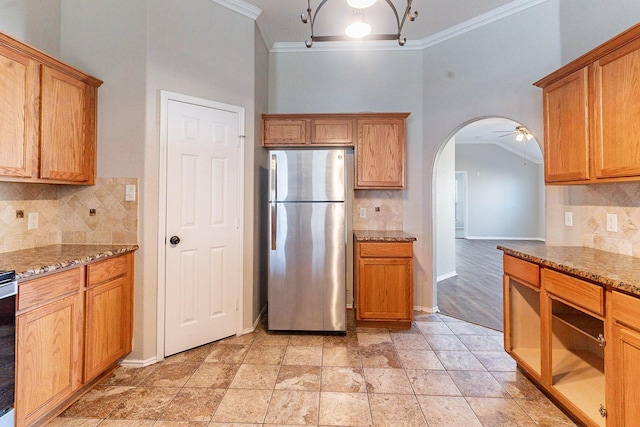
(15, 253), (133, 427)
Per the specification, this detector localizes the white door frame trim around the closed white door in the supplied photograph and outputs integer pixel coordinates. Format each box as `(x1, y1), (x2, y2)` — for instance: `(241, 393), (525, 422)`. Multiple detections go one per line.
(156, 90), (245, 362)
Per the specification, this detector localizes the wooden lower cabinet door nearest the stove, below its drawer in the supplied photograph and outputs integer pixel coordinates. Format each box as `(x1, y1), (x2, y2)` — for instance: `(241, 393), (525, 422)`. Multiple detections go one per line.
(16, 293), (83, 426)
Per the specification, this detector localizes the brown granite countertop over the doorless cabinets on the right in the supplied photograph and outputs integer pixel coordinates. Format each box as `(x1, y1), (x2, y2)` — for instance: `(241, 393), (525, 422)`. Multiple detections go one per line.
(498, 244), (640, 297)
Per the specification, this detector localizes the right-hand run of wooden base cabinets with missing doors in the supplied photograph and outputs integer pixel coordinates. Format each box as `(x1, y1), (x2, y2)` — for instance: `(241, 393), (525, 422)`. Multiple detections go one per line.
(504, 255), (640, 427)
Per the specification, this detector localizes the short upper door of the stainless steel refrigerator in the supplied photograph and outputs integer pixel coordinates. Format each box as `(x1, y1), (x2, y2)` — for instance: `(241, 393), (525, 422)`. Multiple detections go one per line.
(269, 150), (346, 202)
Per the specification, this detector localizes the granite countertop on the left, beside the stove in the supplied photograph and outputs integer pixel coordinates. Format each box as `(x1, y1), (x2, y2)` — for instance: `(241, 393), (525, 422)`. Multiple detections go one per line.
(0, 245), (138, 280)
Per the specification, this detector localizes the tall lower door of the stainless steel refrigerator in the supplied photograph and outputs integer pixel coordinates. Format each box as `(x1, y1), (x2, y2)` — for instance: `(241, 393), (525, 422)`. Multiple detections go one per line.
(269, 202), (346, 331)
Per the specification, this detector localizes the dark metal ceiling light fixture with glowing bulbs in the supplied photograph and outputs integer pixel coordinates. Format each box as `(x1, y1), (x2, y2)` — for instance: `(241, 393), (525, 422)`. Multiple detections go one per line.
(300, 0), (418, 47)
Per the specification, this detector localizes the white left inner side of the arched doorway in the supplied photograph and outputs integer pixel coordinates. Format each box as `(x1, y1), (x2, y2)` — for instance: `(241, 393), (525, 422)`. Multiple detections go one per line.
(435, 137), (457, 281)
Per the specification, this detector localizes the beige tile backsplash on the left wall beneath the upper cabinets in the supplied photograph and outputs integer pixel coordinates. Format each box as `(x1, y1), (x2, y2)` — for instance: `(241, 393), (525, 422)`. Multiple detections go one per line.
(0, 178), (138, 252)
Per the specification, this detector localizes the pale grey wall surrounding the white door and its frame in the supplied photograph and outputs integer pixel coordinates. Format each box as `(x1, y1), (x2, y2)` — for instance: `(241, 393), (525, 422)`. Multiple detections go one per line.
(61, 0), (267, 361)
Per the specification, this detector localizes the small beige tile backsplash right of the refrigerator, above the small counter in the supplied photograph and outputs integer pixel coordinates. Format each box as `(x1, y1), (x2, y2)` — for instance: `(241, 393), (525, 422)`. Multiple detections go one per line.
(353, 190), (402, 230)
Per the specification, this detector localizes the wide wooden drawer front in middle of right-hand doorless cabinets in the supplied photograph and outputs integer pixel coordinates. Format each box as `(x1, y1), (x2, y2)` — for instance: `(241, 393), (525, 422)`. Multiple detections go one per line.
(542, 268), (604, 316)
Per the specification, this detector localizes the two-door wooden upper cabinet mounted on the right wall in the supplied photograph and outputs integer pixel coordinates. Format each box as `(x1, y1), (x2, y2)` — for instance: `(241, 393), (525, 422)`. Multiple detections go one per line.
(535, 24), (640, 184)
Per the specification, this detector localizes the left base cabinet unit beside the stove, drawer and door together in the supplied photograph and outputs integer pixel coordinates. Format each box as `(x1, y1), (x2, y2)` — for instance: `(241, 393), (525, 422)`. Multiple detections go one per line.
(16, 268), (84, 426)
